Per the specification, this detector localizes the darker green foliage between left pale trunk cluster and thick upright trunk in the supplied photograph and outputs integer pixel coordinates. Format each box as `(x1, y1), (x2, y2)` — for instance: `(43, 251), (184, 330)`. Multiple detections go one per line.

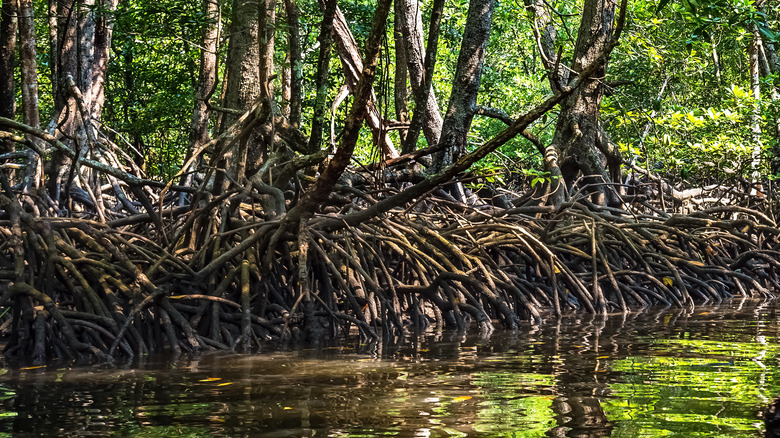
(103, 0), (207, 178)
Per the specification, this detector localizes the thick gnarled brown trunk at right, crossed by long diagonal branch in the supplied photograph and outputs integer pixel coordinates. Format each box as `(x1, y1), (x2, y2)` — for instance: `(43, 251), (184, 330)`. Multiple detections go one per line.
(553, 0), (620, 206)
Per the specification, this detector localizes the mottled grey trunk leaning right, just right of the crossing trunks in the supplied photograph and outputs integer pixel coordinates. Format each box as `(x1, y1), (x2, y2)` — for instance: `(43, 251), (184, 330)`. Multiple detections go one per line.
(433, 0), (495, 171)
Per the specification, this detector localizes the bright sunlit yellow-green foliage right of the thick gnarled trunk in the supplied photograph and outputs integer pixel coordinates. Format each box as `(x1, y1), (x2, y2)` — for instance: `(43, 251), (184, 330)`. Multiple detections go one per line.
(602, 0), (777, 184)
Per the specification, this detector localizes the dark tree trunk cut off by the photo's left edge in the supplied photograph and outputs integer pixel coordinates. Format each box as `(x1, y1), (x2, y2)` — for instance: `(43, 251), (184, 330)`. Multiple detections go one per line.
(0, 0), (17, 154)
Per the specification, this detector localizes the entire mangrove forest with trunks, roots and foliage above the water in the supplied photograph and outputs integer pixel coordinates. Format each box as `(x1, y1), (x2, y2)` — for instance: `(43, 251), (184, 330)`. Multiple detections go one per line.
(0, 0), (780, 365)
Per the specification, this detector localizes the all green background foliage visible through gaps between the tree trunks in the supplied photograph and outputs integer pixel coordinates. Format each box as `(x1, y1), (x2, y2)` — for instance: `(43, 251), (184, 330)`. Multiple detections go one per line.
(12, 0), (780, 184)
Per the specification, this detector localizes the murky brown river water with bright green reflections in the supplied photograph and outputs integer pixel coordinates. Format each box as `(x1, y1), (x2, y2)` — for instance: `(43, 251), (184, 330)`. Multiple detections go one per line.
(0, 303), (780, 437)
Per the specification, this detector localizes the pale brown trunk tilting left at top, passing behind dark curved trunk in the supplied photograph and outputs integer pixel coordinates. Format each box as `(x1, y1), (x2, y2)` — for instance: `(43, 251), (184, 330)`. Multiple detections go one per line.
(331, 0), (398, 159)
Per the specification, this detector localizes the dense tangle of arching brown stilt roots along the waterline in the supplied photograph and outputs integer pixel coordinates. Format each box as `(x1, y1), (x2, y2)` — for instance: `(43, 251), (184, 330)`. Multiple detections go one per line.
(0, 171), (780, 364)
